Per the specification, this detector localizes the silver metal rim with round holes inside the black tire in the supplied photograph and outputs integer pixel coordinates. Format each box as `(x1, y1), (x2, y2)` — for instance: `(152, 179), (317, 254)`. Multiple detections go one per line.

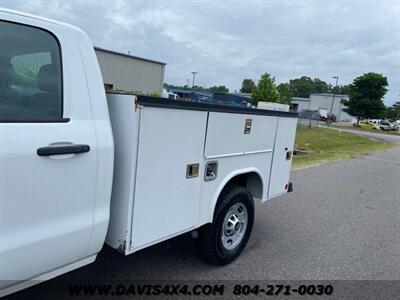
(221, 202), (249, 250)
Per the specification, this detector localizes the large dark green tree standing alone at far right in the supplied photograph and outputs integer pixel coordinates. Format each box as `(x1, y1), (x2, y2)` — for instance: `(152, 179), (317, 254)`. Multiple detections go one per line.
(342, 72), (389, 126)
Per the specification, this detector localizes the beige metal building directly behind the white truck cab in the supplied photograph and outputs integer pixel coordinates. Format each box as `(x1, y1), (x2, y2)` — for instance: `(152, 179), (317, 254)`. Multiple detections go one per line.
(95, 47), (166, 94)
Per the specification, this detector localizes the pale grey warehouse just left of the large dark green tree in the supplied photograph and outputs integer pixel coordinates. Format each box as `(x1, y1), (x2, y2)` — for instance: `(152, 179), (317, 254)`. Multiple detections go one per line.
(291, 93), (352, 122)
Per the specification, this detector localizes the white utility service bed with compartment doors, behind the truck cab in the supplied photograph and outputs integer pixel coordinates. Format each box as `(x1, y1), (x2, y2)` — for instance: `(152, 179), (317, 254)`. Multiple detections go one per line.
(106, 94), (297, 254)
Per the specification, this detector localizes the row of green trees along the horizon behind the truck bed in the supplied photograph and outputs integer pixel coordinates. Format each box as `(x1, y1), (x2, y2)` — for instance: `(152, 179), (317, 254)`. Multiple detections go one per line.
(244, 72), (400, 125)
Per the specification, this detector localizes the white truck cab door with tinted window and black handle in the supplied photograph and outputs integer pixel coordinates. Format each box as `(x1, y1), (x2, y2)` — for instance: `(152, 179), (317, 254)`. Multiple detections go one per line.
(0, 11), (103, 295)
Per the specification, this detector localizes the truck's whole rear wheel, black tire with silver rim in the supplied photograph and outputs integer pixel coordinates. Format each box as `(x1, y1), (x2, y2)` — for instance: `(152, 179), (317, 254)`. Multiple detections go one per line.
(200, 184), (254, 265)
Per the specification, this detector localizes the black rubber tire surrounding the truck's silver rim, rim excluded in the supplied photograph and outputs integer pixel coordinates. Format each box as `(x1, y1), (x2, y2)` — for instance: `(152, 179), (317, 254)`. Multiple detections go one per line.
(199, 184), (254, 266)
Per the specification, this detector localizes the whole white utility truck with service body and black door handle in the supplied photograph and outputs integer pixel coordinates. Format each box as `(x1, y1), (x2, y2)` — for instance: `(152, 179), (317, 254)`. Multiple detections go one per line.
(0, 9), (297, 295)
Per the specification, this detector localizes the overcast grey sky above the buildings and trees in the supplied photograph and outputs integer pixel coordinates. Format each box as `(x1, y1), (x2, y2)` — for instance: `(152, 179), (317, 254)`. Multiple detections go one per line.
(0, 0), (400, 104)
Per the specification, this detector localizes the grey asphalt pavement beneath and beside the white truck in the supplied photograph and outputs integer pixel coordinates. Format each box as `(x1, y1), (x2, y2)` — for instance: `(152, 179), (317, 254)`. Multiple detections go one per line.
(6, 144), (400, 299)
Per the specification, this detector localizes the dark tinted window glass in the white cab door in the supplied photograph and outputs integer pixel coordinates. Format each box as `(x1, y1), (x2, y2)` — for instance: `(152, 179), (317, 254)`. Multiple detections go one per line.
(0, 21), (62, 122)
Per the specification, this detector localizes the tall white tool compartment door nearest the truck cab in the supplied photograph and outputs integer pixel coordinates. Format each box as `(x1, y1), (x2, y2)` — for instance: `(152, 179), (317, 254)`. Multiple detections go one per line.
(131, 107), (207, 250)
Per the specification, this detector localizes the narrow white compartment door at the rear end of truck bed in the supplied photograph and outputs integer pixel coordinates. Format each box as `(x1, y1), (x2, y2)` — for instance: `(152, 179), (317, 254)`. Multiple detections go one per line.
(268, 117), (297, 198)
